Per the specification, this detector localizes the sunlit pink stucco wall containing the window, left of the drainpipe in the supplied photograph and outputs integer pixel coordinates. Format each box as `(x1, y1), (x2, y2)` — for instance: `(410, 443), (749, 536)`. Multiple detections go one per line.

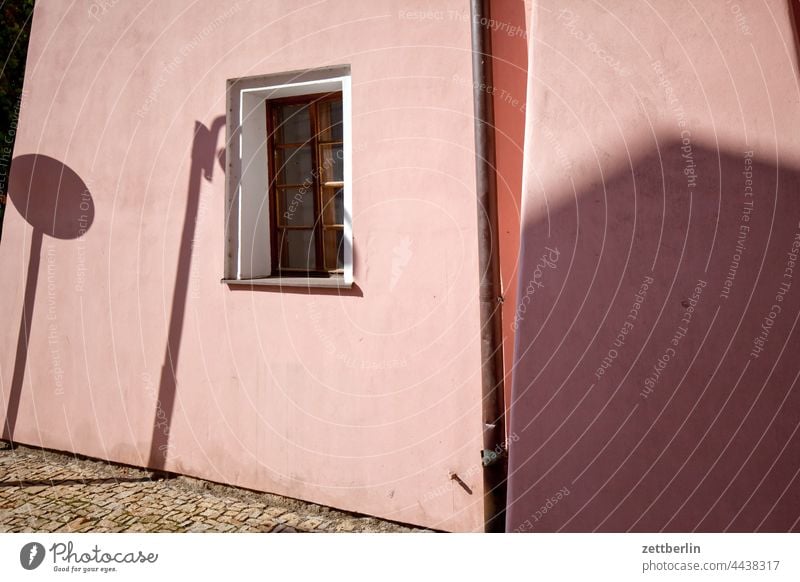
(0, 0), (483, 530)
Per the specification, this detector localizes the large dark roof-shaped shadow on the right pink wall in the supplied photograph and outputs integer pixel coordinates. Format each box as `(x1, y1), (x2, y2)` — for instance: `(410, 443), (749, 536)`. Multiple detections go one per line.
(507, 139), (800, 532)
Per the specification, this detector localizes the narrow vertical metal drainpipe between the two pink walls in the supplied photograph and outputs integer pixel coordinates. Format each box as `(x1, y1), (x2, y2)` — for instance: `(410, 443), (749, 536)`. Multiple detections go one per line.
(470, 0), (508, 532)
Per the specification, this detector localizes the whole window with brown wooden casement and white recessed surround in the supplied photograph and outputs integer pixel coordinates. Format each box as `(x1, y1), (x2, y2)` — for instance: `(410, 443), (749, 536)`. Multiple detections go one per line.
(223, 67), (353, 287)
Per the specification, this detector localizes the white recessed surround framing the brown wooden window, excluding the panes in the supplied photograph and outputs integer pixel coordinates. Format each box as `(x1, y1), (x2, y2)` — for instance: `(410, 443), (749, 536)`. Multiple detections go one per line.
(222, 67), (353, 287)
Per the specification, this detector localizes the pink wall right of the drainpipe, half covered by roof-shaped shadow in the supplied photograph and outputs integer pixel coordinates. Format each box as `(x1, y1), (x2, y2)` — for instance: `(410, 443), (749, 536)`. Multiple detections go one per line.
(508, 0), (800, 531)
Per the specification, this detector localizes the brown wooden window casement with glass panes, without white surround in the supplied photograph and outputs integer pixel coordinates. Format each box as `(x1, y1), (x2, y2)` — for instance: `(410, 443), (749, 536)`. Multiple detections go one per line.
(266, 93), (344, 276)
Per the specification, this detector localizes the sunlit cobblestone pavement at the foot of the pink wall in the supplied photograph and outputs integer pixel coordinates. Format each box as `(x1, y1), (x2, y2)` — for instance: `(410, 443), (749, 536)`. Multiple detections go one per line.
(0, 441), (422, 533)
